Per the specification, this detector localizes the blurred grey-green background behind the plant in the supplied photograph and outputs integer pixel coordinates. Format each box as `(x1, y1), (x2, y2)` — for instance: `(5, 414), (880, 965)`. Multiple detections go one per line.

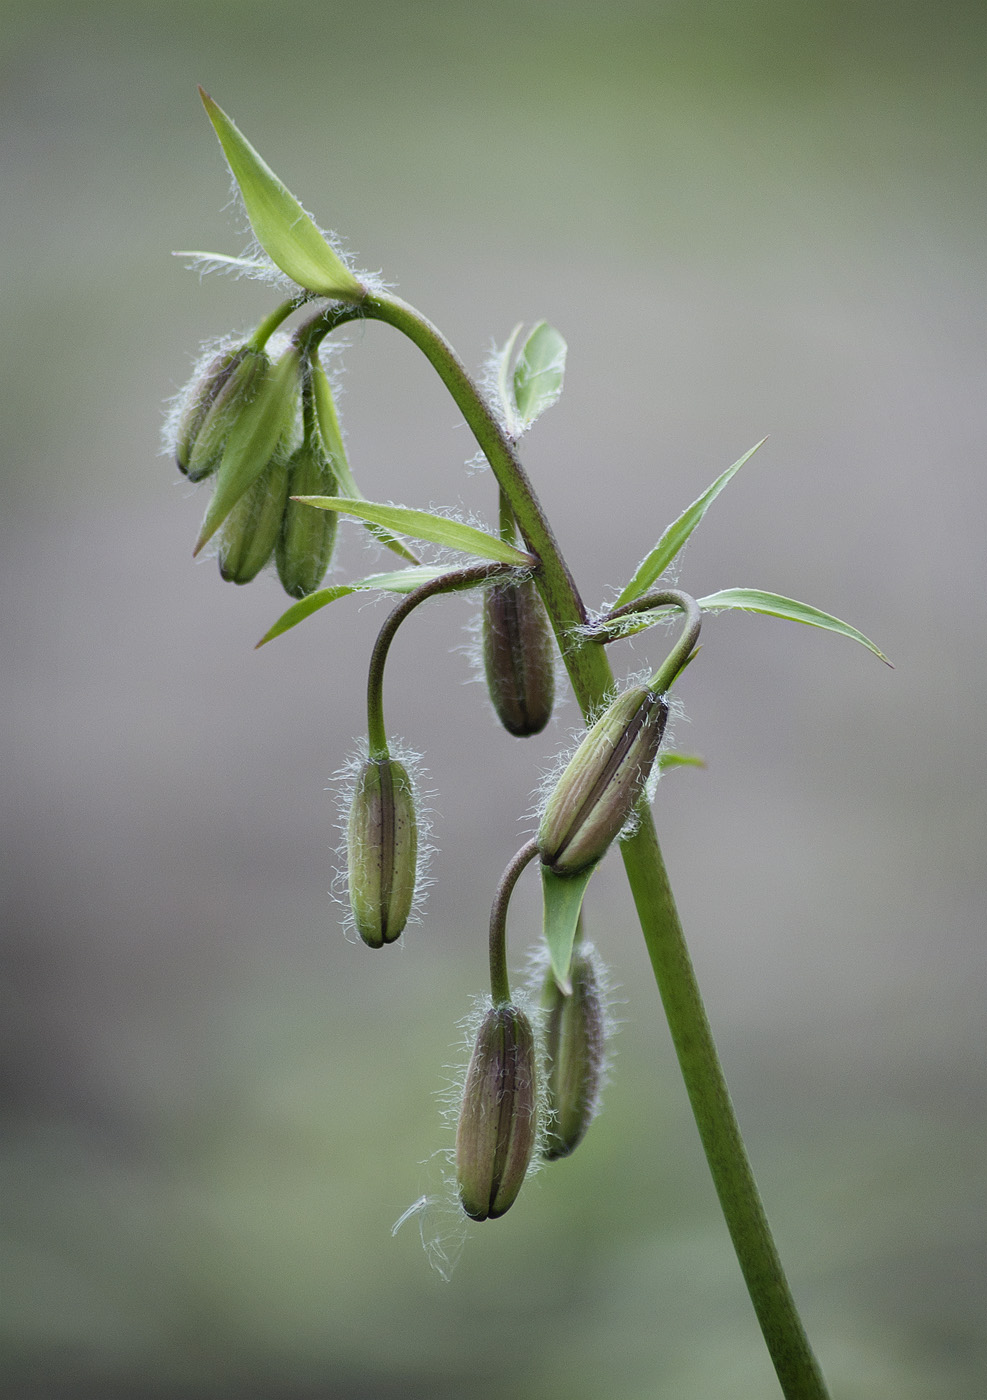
(0, 0), (987, 1400)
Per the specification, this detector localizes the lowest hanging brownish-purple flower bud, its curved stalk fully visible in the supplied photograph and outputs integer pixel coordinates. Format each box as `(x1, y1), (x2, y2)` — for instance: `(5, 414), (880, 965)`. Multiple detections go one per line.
(456, 1005), (538, 1221)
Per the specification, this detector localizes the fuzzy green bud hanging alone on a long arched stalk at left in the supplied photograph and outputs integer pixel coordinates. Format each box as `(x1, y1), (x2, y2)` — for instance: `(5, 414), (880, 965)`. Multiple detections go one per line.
(346, 759), (419, 948)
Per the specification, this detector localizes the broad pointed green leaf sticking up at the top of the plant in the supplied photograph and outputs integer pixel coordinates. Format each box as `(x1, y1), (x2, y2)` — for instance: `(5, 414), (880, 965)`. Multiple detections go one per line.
(199, 88), (367, 301)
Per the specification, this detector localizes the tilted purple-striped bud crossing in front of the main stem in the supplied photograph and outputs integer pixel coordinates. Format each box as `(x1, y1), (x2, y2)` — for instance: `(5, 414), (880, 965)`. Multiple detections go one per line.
(538, 686), (668, 875)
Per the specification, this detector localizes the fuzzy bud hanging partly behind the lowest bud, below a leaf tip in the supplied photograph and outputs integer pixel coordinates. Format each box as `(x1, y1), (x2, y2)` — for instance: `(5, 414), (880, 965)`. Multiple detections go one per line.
(542, 946), (603, 1161)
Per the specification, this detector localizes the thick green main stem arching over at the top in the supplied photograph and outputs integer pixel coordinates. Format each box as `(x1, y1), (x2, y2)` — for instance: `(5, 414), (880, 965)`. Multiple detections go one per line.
(316, 295), (827, 1400)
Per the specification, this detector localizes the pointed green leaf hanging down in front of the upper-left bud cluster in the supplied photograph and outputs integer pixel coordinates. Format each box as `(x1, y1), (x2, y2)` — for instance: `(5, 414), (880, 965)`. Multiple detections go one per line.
(192, 349), (301, 557)
